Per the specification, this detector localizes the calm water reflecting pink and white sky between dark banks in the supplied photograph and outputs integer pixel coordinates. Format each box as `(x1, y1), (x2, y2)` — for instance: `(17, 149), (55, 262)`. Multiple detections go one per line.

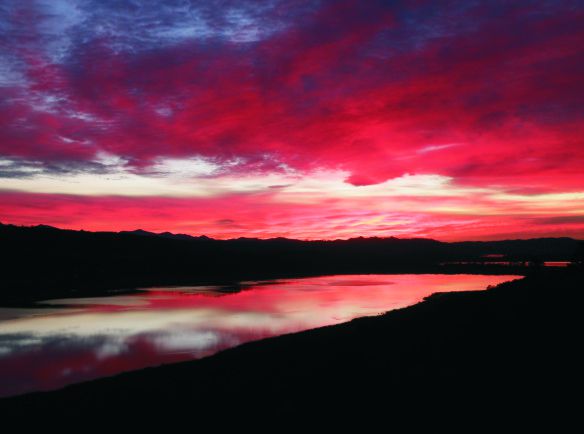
(0, 275), (517, 396)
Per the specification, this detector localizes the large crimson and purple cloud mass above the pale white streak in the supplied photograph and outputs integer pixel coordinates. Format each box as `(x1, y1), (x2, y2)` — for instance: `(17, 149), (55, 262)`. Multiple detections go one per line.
(0, 1), (584, 236)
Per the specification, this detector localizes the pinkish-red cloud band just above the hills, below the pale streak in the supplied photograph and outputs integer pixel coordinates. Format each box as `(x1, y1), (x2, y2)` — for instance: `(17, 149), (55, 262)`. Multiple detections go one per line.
(0, 193), (584, 241)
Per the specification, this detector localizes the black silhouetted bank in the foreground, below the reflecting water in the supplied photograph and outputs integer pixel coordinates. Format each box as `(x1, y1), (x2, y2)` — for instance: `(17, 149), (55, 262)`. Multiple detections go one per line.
(0, 267), (572, 424)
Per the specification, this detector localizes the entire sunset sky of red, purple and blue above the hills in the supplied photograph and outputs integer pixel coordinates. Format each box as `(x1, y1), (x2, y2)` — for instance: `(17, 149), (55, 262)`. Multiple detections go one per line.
(0, 0), (584, 241)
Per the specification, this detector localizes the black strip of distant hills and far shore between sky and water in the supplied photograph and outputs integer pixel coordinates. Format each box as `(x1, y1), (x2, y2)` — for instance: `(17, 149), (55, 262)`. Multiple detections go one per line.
(0, 224), (582, 306)
